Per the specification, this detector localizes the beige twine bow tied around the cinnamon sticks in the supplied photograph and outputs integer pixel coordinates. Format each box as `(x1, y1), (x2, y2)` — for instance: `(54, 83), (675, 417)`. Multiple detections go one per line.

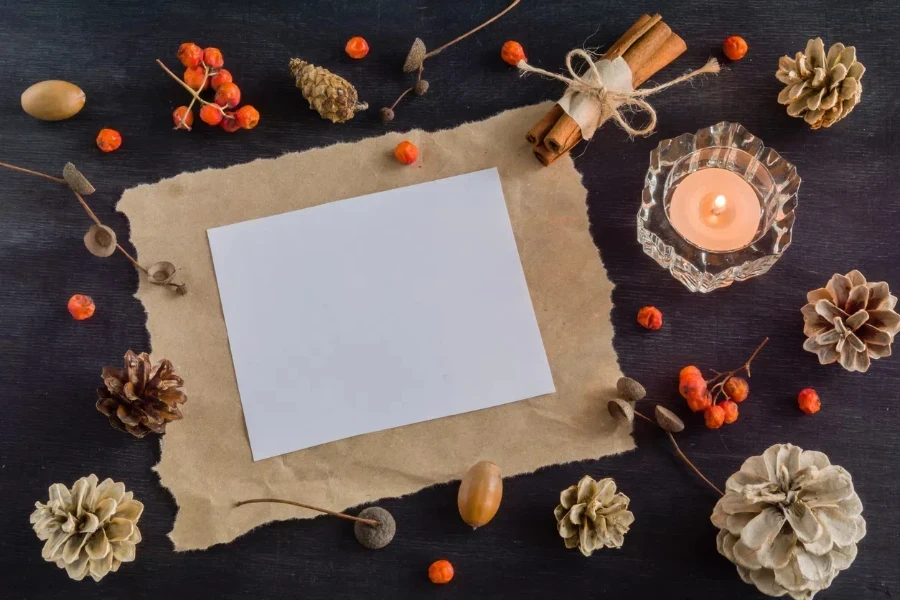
(518, 49), (720, 137)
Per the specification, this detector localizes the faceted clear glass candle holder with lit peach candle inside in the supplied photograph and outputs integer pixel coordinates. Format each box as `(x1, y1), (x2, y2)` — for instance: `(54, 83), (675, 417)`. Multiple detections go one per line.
(637, 121), (800, 292)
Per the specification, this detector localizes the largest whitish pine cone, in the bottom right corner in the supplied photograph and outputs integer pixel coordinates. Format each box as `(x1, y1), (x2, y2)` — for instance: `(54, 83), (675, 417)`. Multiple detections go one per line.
(711, 444), (866, 600)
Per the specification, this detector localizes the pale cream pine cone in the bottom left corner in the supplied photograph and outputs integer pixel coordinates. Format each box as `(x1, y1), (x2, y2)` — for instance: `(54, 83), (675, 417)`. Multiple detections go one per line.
(31, 475), (144, 581)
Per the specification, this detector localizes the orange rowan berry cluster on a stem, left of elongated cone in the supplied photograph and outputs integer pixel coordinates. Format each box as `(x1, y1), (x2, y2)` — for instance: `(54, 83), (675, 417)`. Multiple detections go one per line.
(166, 42), (259, 132)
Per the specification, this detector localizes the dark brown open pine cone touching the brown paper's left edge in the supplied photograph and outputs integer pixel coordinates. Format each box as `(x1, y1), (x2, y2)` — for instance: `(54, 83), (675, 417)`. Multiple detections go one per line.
(97, 350), (187, 437)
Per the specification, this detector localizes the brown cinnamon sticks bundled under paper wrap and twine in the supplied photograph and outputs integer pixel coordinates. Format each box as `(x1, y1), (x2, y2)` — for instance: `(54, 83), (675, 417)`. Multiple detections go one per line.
(525, 14), (687, 166)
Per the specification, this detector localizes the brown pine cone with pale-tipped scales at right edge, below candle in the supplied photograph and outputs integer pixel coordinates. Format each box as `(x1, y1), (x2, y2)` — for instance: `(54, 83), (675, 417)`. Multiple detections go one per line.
(801, 271), (900, 372)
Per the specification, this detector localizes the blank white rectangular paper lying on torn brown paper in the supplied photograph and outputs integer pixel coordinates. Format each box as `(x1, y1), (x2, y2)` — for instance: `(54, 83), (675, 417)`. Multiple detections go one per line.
(207, 169), (554, 460)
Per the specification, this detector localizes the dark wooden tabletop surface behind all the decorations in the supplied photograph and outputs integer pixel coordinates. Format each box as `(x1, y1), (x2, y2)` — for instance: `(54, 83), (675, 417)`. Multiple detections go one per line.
(0, 0), (900, 599)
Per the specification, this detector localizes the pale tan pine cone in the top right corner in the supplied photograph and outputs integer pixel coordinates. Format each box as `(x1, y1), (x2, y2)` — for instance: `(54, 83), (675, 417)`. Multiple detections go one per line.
(775, 38), (866, 129)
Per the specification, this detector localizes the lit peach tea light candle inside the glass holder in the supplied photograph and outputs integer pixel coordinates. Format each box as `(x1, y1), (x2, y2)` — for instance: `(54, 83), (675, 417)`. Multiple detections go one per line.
(669, 168), (762, 252)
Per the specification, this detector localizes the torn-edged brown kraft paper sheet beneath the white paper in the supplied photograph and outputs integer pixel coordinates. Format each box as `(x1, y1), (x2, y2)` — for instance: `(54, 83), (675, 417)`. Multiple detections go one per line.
(118, 103), (634, 550)
